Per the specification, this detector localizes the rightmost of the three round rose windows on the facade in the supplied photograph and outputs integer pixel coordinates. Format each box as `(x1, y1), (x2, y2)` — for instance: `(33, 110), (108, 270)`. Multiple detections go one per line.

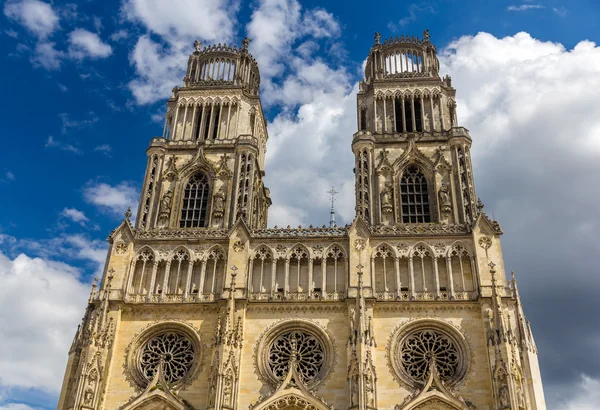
(399, 330), (460, 384)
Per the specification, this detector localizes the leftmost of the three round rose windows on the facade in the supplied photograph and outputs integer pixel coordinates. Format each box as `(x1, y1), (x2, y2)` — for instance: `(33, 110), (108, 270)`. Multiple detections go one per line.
(139, 332), (195, 383)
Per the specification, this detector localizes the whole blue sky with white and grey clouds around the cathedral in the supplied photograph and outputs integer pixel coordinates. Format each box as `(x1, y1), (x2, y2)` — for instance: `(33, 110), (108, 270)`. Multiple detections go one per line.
(0, 0), (600, 410)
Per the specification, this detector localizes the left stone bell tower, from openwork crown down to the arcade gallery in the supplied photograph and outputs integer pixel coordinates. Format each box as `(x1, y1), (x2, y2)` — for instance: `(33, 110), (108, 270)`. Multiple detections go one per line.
(136, 39), (271, 230)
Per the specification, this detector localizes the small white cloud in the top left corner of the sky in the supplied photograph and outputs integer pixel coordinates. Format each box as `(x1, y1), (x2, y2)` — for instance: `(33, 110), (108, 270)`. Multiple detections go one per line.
(4, 0), (59, 39)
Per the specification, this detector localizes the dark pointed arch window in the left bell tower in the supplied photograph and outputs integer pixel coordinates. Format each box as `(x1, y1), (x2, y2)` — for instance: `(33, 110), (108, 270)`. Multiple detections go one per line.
(179, 172), (210, 228)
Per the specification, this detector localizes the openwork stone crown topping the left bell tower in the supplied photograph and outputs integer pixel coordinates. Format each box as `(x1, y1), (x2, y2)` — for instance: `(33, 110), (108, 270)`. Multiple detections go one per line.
(183, 38), (260, 96)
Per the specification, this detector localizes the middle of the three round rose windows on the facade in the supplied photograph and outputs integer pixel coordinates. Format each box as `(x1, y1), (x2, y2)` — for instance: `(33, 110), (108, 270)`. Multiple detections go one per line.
(268, 331), (325, 385)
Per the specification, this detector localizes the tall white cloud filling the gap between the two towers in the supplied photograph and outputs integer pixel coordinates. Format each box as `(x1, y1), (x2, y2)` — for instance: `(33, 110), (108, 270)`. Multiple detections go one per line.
(247, 0), (357, 226)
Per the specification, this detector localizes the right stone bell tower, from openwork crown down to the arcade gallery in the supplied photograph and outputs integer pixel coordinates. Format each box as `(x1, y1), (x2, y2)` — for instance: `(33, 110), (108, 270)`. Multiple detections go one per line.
(352, 32), (476, 225)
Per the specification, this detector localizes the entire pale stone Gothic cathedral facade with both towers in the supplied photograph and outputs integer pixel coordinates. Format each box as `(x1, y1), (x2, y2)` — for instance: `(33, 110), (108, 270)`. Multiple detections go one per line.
(58, 31), (546, 410)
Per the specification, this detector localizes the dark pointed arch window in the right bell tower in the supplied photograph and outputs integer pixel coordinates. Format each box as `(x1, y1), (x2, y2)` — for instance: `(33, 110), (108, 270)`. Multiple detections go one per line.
(400, 165), (431, 223)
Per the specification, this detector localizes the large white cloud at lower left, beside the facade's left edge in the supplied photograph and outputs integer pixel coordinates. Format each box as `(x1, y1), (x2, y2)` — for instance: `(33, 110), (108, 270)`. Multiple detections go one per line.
(0, 248), (89, 392)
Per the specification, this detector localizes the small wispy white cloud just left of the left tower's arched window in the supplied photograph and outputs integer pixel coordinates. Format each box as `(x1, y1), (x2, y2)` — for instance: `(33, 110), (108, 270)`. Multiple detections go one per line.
(83, 181), (139, 215)
